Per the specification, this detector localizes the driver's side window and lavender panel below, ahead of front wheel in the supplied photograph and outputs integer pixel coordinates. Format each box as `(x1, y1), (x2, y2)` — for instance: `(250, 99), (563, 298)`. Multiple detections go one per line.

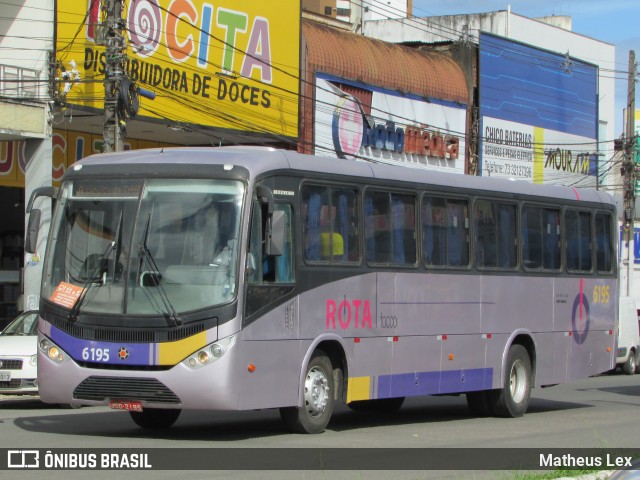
(239, 201), (300, 409)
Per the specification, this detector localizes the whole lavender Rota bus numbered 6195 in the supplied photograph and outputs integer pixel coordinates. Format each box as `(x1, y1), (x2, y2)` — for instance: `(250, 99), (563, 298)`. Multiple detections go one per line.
(26, 147), (619, 433)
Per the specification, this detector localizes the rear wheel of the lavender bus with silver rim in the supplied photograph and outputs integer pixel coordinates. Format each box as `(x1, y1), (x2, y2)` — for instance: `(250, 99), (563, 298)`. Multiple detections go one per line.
(491, 345), (531, 418)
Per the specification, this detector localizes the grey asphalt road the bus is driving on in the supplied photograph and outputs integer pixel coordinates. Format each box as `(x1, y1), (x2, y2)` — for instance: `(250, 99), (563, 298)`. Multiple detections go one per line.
(0, 375), (640, 480)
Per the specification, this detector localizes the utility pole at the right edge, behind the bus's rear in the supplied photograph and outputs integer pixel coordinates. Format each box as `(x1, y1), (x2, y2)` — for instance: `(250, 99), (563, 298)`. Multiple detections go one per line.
(622, 50), (636, 296)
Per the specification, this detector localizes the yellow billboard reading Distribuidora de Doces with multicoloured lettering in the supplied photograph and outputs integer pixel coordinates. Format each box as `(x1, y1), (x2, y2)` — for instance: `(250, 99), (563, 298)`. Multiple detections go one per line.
(56, 0), (300, 138)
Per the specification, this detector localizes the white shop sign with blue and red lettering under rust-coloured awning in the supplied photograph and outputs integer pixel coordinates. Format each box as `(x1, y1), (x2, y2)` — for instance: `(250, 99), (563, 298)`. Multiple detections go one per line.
(314, 79), (466, 173)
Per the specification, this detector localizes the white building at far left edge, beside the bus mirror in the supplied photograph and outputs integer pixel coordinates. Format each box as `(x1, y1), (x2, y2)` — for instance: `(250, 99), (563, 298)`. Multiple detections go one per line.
(0, 0), (54, 322)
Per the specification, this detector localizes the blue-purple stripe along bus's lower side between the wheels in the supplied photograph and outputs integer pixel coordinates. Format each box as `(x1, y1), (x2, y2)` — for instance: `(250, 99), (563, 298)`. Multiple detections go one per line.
(378, 368), (493, 398)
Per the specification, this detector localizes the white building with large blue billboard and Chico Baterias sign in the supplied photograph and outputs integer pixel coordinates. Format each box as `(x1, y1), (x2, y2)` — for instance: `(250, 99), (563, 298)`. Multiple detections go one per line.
(363, 10), (615, 189)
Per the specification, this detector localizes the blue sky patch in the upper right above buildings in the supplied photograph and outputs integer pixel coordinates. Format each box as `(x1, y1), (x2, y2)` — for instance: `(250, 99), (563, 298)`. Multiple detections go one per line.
(413, 0), (640, 136)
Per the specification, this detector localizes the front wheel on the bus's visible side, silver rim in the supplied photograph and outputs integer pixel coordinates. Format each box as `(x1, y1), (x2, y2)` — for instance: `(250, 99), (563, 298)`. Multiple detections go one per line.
(280, 350), (335, 433)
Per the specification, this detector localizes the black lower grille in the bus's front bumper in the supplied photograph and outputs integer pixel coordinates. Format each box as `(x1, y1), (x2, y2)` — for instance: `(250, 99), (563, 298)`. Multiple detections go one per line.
(73, 376), (180, 404)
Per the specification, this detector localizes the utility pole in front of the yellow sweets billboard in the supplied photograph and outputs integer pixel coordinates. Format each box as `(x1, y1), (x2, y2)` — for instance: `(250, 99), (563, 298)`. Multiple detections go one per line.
(102, 0), (126, 152)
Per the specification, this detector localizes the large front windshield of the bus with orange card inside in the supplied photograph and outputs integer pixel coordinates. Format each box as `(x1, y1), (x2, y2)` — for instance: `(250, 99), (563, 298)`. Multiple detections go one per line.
(43, 179), (244, 316)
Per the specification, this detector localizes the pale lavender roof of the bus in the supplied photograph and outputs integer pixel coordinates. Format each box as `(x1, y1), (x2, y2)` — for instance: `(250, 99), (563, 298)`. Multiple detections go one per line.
(74, 146), (615, 205)
